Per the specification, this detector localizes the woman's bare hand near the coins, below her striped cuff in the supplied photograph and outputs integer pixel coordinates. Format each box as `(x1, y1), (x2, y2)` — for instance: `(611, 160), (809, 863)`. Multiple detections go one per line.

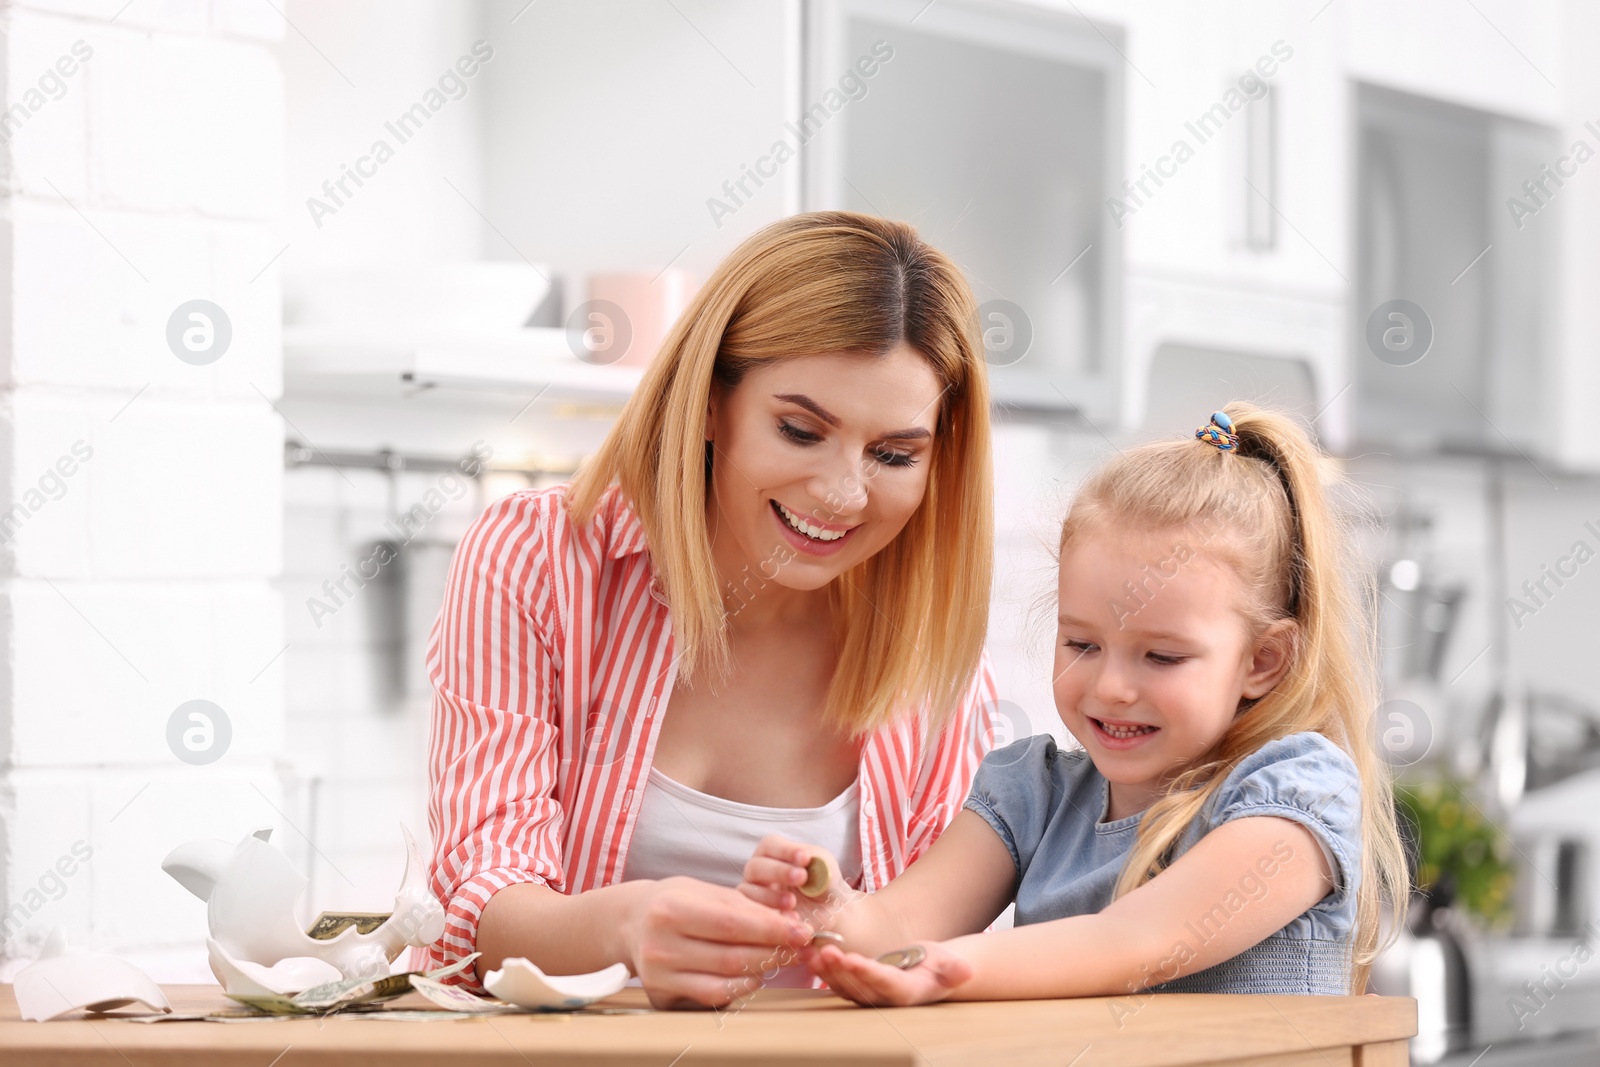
(624, 878), (811, 1008)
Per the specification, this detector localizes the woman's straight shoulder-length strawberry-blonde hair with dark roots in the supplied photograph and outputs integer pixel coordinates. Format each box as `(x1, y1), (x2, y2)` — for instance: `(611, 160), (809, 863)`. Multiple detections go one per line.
(568, 211), (994, 734)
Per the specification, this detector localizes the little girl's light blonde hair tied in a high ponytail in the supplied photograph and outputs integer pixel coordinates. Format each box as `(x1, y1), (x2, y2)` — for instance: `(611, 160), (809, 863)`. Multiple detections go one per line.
(1061, 403), (1410, 993)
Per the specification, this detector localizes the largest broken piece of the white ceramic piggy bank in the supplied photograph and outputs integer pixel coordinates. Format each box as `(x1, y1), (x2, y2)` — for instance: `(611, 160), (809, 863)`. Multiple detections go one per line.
(162, 825), (445, 985)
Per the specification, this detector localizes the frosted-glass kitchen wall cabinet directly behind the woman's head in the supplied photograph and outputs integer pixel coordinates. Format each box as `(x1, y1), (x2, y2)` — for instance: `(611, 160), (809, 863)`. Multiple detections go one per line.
(798, 0), (1126, 421)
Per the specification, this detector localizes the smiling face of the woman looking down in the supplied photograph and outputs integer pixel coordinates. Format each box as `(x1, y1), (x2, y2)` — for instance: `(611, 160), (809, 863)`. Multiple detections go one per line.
(706, 342), (944, 590)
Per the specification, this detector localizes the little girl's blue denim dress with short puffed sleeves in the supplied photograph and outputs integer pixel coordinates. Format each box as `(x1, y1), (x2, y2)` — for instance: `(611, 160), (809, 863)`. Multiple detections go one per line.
(963, 733), (1362, 995)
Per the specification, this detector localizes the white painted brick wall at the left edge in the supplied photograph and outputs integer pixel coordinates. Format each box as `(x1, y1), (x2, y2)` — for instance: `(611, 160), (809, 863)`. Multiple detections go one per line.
(0, 0), (284, 977)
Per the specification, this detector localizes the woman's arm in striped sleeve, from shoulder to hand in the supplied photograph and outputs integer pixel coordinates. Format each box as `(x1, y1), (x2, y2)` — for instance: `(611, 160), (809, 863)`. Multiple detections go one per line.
(429, 494), (811, 1008)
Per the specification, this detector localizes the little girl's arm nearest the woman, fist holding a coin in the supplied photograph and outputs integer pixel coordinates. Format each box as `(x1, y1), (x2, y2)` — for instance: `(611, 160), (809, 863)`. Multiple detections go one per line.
(739, 809), (1016, 955)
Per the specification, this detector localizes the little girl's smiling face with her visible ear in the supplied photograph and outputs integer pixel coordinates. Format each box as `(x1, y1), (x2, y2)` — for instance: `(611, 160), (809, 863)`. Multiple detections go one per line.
(1054, 523), (1294, 819)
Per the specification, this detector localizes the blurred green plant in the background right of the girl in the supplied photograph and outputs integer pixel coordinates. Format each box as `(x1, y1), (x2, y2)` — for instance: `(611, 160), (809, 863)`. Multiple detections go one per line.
(1395, 776), (1514, 926)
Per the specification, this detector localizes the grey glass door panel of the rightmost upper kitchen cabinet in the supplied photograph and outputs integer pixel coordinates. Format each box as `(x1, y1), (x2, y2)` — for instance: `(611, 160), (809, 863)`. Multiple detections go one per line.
(1350, 85), (1562, 456)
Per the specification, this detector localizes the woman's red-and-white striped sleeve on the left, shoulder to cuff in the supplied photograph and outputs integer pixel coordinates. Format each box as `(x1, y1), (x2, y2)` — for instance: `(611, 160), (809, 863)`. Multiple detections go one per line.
(427, 493), (565, 984)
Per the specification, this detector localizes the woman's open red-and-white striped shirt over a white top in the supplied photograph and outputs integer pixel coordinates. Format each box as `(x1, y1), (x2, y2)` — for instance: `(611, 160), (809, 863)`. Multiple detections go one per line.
(427, 486), (995, 985)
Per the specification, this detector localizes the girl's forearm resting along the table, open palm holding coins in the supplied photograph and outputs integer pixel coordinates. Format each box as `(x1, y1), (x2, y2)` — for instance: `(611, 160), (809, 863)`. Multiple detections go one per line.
(806, 816), (1333, 1005)
